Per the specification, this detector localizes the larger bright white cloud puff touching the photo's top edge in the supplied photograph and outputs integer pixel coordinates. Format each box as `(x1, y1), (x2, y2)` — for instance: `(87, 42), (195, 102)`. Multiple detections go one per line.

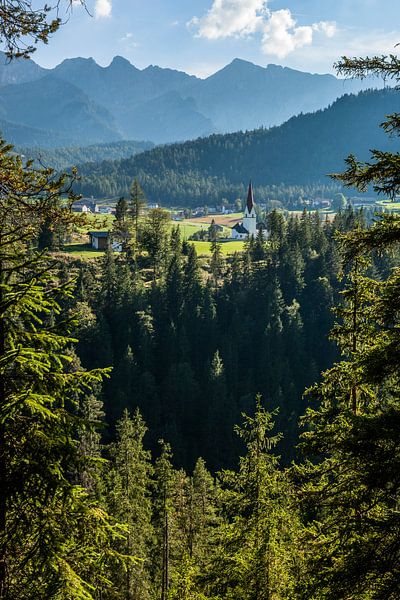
(188, 0), (267, 40)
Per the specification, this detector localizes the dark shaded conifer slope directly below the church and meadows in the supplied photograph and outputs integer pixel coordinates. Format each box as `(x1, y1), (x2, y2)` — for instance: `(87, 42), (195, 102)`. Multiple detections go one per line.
(68, 211), (389, 470)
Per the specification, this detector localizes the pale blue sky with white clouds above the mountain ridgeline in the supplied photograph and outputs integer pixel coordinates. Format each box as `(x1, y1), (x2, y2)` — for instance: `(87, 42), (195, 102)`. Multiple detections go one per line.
(33, 0), (400, 77)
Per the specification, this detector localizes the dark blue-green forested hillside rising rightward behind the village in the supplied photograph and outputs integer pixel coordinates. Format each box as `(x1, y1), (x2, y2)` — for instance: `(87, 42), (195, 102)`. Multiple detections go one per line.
(71, 89), (400, 206)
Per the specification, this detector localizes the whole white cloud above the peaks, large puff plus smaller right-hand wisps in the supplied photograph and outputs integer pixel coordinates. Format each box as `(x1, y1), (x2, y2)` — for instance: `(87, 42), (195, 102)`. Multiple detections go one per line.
(188, 0), (336, 58)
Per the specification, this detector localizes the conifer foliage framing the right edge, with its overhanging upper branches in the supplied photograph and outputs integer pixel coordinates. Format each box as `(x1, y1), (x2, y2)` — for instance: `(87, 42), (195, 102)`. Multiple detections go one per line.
(298, 52), (400, 600)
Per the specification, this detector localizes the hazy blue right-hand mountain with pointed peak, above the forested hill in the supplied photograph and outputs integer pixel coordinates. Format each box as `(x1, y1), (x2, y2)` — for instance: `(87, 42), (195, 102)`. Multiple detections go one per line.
(181, 59), (365, 132)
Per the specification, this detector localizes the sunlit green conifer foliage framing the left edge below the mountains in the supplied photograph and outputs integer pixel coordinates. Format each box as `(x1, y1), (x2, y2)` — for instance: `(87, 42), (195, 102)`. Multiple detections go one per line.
(0, 143), (126, 600)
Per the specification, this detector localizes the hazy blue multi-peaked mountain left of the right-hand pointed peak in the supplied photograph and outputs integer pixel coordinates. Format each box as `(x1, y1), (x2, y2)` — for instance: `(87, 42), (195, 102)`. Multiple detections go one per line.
(54, 56), (203, 142)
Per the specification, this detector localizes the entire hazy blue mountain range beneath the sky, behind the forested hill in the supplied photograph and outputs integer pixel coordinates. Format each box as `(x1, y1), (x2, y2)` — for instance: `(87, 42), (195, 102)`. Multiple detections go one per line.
(0, 55), (371, 147)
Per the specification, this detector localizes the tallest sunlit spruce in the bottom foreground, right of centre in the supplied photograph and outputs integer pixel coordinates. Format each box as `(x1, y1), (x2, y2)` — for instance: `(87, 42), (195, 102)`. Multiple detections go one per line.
(203, 397), (299, 600)
